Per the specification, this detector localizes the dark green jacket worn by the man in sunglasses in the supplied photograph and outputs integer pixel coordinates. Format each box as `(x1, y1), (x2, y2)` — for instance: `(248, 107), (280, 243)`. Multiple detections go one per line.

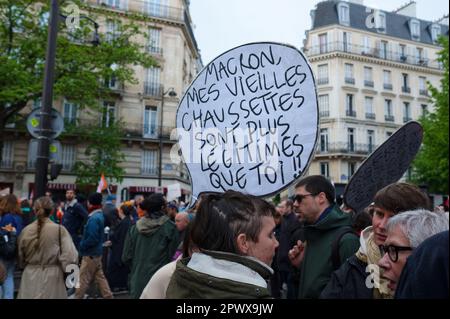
(299, 205), (359, 299)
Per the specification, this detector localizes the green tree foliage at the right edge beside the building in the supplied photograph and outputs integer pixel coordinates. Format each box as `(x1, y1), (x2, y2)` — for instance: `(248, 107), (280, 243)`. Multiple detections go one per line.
(413, 37), (449, 194)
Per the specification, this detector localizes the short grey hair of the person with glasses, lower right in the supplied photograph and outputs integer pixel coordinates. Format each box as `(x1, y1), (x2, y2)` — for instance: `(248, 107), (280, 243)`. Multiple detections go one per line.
(386, 209), (449, 248)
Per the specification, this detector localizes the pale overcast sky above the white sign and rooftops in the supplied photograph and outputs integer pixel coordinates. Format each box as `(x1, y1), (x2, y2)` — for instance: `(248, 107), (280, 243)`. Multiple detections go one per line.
(190, 0), (449, 65)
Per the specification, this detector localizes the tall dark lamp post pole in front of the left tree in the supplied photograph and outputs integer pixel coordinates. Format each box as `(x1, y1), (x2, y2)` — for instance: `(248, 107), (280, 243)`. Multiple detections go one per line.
(34, 0), (59, 198)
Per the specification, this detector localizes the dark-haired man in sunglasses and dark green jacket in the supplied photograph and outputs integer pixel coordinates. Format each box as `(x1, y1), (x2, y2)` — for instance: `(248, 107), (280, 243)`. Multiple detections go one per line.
(289, 175), (359, 298)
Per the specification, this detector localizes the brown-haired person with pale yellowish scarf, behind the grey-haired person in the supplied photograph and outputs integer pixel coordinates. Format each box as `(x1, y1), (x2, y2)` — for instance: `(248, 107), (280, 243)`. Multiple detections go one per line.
(320, 183), (430, 299)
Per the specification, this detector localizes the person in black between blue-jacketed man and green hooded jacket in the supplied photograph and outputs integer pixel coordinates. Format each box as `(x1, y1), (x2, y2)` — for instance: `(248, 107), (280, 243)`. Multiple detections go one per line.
(105, 204), (134, 291)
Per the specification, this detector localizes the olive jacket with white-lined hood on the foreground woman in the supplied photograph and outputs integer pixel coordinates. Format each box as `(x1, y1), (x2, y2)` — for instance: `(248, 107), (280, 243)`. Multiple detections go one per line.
(166, 251), (273, 299)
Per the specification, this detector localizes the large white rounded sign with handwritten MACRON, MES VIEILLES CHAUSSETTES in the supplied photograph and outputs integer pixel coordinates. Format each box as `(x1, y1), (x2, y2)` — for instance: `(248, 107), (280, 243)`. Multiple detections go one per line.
(172, 42), (318, 199)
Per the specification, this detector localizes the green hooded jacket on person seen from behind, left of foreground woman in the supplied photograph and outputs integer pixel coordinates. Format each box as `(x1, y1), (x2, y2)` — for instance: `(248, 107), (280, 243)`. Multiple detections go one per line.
(122, 215), (178, 299)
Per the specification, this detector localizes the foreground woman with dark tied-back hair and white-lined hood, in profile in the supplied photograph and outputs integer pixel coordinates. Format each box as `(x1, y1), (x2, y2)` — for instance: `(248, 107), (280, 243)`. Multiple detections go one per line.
(166, 191), (278, 299)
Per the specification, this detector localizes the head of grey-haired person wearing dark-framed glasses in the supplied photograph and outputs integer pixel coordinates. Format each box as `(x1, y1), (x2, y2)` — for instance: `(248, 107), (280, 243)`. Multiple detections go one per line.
(378, 209), (449, 293)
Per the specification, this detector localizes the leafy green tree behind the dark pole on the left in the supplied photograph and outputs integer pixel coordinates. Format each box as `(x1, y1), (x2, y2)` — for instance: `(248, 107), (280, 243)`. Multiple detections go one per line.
(0, 0), (156, 182)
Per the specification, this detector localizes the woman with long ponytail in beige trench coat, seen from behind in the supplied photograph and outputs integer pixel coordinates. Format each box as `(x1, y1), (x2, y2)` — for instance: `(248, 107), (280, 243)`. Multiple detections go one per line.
(18, 196), (78, 299)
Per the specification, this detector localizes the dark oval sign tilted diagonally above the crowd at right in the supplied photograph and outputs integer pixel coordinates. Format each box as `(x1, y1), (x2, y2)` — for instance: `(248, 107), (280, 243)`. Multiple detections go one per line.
(344, 121), (423, 212)
